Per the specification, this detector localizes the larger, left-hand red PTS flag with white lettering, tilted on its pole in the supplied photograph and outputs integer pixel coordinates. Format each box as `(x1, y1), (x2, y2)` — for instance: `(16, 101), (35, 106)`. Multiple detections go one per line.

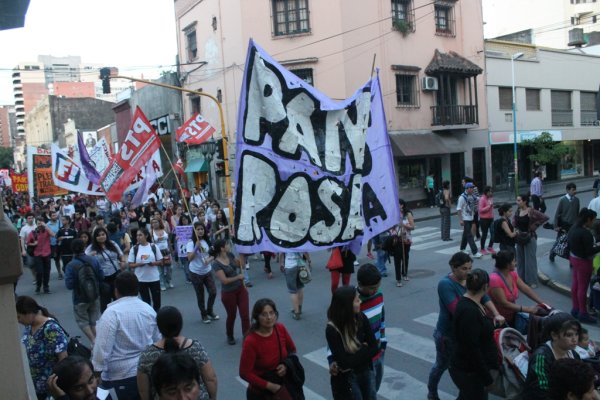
(100, 107), (160, 202)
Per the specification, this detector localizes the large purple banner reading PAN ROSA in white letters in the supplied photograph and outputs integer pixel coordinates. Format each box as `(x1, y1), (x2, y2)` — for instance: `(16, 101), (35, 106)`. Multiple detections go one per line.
(234, 40), (400, 253)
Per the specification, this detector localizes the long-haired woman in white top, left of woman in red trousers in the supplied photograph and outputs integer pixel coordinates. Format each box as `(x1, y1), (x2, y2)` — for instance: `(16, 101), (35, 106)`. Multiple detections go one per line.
(186, 222), (219, 324)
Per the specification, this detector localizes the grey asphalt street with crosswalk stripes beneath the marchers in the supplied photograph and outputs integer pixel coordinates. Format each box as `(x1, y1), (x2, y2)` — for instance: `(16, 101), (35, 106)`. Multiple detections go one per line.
(12, 188), (600, 399)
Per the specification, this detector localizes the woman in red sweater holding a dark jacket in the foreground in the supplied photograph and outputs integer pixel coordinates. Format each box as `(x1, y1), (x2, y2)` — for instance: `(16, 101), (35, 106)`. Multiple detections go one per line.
(240, 299), (296, 400)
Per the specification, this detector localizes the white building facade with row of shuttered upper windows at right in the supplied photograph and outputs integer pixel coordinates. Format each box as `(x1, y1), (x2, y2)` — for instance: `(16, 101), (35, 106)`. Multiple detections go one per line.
(486, 40), (600, 188)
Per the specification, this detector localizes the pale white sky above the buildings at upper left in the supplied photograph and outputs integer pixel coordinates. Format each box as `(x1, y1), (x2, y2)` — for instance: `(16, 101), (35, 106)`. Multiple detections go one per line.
(0, 0), (177, 105)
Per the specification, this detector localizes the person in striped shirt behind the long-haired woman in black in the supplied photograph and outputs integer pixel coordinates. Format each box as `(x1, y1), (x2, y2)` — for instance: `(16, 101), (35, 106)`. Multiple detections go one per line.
(356, 264), (387, 391)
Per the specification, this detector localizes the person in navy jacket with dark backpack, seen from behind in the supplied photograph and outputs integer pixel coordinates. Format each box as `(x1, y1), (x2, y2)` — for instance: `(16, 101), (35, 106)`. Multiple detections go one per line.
(65, 239), (104, 345)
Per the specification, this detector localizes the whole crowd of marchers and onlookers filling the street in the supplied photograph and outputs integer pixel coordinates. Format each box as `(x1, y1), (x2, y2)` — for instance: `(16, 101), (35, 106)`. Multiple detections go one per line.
(4, 178), (600, 400)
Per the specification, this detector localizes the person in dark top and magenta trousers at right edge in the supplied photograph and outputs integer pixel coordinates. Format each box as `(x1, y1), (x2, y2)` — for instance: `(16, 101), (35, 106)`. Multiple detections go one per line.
(567, 208), (600, 324)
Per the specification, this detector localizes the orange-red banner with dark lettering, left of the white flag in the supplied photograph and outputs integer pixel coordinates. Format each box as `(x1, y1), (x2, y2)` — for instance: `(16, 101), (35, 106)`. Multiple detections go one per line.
(27, 146), (68, 198)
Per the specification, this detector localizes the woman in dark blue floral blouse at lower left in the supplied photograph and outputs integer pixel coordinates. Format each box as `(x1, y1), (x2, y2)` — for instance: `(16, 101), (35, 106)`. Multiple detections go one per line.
(16, 296), (68, 400)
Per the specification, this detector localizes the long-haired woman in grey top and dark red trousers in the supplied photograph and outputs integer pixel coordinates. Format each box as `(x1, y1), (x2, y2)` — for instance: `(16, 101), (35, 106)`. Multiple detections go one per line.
(209, 239), (250, 345)
